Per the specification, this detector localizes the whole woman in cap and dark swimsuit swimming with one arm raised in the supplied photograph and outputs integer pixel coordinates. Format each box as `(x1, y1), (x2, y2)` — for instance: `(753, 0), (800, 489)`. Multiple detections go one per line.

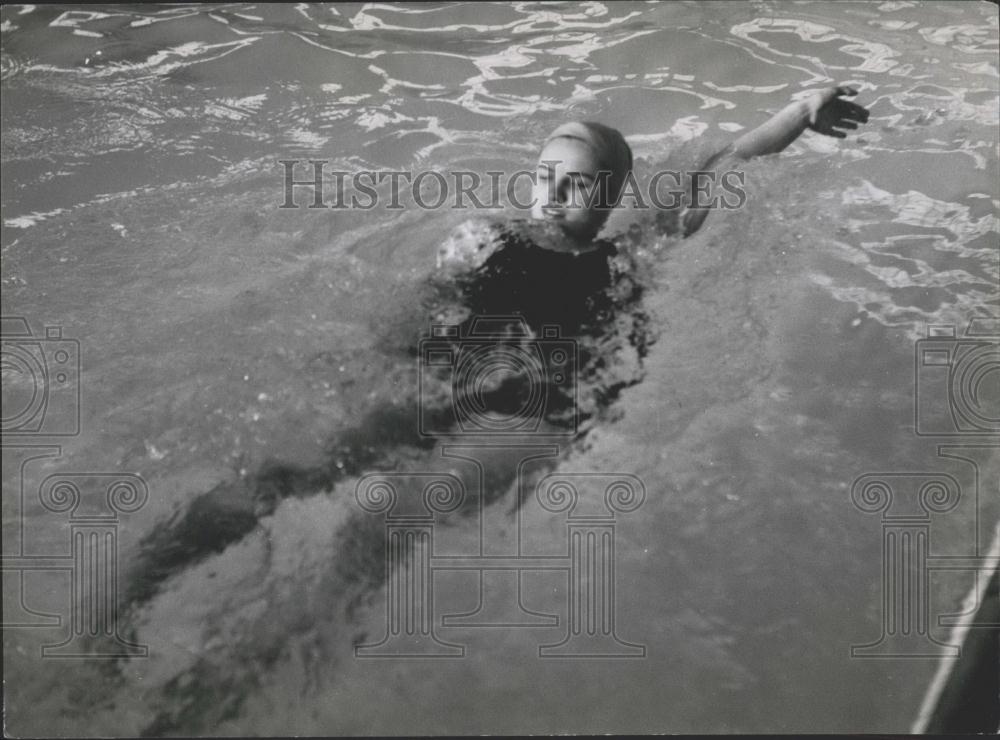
(129, 87), (868, 603)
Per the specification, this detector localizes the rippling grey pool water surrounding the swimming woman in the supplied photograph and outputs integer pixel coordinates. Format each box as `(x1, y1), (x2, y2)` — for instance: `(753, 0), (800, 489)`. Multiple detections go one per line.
(0, 2), (1000, 735)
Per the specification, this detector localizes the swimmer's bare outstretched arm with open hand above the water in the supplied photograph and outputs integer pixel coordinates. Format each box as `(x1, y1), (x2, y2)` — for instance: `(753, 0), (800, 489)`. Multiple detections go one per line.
(684, 86), (868, 236)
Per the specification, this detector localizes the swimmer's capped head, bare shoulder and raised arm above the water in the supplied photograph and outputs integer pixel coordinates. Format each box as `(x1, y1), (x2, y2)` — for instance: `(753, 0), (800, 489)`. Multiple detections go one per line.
(438, 86), (868, 270)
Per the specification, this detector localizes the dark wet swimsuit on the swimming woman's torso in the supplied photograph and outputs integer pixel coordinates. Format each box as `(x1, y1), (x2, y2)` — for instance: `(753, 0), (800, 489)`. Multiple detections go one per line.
(424, 215), (650, 428)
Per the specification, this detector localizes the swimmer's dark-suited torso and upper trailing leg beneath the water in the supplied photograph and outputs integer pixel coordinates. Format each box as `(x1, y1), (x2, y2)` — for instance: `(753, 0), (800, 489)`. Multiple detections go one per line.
(127, 219), (654, 605)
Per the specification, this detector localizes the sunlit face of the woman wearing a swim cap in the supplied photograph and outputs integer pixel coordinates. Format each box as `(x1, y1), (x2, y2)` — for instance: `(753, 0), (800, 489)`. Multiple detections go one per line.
(531, 137), (609, 241)
